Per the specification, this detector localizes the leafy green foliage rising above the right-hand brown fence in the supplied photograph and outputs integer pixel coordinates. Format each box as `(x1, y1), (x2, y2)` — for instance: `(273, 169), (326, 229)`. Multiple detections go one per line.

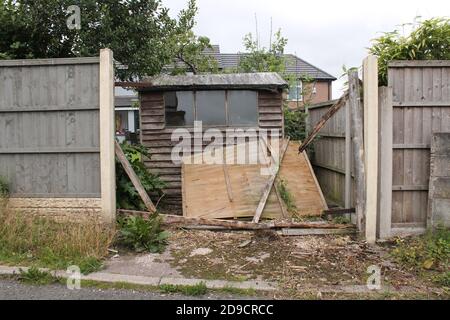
(369, 18), (450, 85)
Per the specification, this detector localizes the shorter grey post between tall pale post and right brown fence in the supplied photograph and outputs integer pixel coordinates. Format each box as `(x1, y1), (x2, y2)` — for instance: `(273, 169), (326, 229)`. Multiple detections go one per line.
(378, 87), (393, 239)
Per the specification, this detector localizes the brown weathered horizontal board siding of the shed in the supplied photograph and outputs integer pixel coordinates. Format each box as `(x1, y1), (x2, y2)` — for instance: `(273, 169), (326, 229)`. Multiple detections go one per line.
(140, 91), (283, 207)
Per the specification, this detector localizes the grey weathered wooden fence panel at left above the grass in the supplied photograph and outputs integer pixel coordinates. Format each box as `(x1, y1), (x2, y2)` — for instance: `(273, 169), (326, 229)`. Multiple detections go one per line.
(0, 58), (100, 198)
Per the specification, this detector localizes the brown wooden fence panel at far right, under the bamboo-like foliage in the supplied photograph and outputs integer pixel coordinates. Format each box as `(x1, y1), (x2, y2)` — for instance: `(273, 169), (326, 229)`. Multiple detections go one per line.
(388, 61), (450, 229)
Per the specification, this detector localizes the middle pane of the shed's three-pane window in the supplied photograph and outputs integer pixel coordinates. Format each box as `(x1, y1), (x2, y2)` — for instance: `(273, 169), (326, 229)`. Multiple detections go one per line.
(197, 91), (226, 126)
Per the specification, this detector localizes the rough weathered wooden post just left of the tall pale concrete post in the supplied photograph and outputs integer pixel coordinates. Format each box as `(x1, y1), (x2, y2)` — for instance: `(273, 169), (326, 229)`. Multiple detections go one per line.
(348, 70), (366, 233)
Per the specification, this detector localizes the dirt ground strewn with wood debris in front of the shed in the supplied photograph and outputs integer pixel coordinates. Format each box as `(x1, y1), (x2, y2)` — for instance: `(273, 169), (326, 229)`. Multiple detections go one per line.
(164, 229), (449, 299)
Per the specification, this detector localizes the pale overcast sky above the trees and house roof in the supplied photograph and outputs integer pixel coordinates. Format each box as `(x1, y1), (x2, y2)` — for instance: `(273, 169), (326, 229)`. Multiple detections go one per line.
(162, 0), (450, 98)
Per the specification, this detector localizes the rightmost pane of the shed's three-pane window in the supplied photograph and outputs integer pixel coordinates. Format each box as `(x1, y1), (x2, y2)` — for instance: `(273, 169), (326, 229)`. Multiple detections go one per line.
(228, 91), (258, 126)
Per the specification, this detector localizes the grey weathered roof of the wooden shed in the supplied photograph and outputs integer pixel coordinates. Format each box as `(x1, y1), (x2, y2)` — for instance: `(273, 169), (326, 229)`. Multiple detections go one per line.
(136, 72), (288, 91)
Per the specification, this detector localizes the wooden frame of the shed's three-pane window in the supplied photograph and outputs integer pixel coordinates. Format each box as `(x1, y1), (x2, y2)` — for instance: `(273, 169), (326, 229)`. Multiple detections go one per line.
(163, 89), (259, 129)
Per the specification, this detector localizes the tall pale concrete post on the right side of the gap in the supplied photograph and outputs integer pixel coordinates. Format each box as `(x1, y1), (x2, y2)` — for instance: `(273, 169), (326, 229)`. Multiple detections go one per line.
(363, 56), (379, 243)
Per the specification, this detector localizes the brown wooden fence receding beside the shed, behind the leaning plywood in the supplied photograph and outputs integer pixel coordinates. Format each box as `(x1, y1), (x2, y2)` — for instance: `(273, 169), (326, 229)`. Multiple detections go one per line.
(307, 100), (354, 208)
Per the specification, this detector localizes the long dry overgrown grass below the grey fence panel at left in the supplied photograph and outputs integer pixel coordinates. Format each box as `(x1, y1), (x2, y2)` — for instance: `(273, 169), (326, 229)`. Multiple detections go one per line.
(0, 202), (115, 274)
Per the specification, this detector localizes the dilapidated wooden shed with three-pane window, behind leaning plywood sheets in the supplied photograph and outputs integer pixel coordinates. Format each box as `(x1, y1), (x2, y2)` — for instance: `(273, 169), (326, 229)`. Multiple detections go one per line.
(137, 73), (288, 207)
